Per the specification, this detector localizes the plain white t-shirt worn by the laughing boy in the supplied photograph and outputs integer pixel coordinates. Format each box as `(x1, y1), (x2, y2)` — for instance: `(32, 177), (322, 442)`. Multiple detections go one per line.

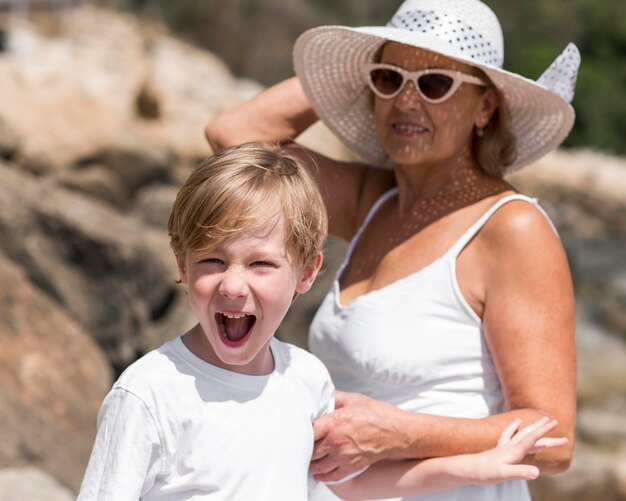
(78, 338), (334, 501)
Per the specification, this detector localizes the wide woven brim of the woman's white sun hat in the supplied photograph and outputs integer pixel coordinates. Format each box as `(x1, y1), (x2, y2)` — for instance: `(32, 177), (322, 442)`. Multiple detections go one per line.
(293, 26), (574, 173)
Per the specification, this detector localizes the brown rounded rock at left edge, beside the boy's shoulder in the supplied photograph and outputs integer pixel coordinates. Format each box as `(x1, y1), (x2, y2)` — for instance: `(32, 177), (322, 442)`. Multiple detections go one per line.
(0, 254), (112, 490)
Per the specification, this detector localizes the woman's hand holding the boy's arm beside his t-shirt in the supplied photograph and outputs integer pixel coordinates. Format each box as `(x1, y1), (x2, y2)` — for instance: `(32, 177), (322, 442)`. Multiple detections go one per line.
(310, 391), (406, 482)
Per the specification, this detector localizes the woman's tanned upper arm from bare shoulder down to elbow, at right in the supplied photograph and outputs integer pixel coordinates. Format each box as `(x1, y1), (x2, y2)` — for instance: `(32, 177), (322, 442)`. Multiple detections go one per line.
(468, 201), (576, 473)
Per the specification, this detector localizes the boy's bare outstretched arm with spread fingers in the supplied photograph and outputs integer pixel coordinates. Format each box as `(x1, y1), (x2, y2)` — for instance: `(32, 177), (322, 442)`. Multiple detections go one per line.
(328, 418), (567, 500)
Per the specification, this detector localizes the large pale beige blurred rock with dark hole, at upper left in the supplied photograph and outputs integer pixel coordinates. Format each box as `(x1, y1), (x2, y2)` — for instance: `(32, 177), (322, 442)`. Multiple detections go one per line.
(0, 5), (246, 171)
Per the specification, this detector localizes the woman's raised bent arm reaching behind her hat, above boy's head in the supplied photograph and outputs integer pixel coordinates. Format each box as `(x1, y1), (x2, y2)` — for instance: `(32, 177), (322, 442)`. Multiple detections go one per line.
(204, 77), (395, 240)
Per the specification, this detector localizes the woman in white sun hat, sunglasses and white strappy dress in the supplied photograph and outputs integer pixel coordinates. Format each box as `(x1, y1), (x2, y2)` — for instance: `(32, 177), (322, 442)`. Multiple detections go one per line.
(206, 0), (580, 501)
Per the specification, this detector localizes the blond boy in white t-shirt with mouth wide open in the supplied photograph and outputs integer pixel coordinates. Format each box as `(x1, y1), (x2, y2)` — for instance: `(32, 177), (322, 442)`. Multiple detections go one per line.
(79, 144), (552, 501)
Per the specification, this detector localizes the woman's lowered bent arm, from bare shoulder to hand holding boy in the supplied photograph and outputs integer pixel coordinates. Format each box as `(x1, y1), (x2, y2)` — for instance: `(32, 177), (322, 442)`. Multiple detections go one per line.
(311, 202), (576, 481)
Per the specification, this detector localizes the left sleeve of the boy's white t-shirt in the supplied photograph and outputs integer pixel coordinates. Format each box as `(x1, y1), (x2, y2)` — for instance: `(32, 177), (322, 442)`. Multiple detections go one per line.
(78, 388), (162, 501)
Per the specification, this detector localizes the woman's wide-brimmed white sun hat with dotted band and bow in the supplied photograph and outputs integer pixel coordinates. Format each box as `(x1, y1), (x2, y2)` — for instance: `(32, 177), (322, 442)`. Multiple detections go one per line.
(293, 0), (580, 173)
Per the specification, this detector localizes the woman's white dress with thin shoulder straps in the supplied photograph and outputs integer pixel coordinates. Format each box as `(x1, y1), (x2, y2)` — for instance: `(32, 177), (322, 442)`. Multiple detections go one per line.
(309, 188), (547, 501)
